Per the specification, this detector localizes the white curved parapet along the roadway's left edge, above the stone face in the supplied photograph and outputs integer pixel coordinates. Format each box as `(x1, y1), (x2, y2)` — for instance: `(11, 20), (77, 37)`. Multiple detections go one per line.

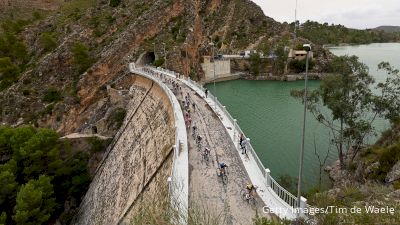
(129, 63), (189, 224)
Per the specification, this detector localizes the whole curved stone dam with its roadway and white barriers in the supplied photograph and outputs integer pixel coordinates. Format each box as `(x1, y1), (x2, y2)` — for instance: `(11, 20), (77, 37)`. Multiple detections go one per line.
(72, 63), (307, 224)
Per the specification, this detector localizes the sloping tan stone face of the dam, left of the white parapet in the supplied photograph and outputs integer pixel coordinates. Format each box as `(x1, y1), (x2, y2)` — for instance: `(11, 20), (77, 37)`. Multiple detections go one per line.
(72, 75), (175, 225)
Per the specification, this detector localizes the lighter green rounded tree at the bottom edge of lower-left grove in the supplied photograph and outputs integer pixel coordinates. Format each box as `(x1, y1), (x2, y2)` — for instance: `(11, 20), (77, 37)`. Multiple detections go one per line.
(13, 175), (57, 225)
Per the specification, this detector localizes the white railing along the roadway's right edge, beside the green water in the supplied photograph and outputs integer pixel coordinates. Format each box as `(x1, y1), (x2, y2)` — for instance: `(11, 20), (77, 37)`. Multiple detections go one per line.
(151, 67), (309, 218)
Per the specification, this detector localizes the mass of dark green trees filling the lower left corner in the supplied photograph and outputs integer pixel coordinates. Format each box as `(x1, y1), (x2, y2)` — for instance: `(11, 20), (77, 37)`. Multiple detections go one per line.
(0, 127), (90, 224)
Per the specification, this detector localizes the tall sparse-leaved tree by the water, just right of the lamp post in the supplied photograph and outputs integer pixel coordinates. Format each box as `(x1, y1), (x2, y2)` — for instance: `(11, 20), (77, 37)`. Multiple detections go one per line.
(291, 56), (378, 168)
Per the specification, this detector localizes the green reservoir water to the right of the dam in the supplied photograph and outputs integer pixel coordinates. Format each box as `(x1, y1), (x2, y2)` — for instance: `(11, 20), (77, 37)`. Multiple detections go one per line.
(207, 44), (400, 190)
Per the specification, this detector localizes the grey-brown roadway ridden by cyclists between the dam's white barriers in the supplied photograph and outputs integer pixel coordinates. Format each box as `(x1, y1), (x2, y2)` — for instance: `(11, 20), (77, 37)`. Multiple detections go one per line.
(165, 80), (267, 225)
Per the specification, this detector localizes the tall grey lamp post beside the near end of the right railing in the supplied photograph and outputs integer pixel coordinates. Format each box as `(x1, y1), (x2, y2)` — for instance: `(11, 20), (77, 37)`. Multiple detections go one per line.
(297, 44), (311, 218)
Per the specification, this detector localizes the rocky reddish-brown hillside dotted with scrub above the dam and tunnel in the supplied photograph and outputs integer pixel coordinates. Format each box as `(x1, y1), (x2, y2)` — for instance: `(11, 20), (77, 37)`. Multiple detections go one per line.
(0, 0), (290, 134)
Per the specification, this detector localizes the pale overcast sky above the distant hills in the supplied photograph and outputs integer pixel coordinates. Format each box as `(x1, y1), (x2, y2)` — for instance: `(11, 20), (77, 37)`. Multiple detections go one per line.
(252, 0), (400, 29)
